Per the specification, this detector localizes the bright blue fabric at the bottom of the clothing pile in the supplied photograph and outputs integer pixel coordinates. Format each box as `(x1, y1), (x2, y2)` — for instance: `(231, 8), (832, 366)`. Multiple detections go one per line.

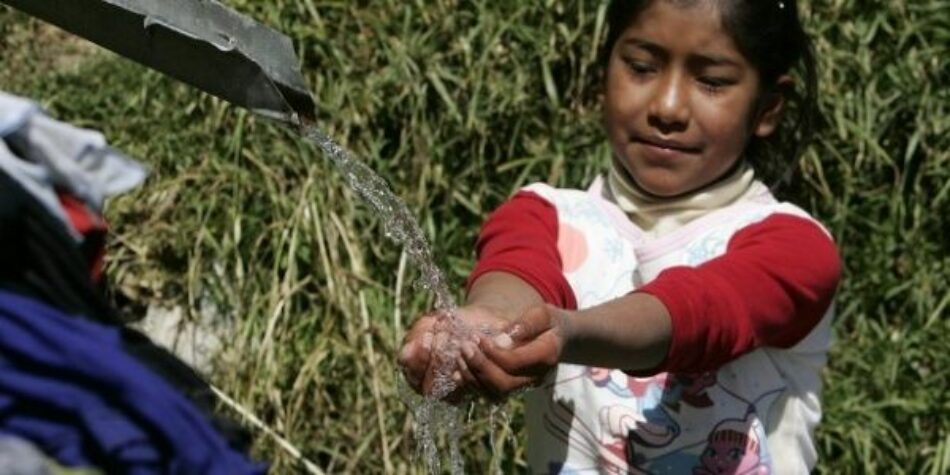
(0, 291), (266, 475)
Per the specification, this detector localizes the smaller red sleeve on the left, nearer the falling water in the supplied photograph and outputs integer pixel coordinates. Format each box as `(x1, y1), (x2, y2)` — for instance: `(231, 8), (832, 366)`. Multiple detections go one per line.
(468, 191), (577, 310)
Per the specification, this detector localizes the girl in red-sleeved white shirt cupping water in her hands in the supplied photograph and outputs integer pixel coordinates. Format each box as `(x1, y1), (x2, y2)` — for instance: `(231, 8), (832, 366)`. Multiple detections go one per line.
(400, 0), (840, 474)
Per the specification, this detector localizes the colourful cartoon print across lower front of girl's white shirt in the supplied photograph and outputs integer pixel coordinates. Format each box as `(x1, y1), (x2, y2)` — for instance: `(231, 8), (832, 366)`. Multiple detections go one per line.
(543, 358), (783, 475)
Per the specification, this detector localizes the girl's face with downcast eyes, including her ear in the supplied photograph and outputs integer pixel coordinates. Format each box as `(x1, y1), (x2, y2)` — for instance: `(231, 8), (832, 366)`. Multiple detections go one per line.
(604, 0), (782, 197)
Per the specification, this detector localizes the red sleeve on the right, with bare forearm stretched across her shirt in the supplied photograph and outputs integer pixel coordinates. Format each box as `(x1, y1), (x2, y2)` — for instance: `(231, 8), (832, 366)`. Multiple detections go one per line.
(638, 214), (841, 372)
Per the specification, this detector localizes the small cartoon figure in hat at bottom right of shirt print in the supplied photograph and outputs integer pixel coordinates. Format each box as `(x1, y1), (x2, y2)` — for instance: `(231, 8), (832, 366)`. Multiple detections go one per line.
(693, 412), (769, 475)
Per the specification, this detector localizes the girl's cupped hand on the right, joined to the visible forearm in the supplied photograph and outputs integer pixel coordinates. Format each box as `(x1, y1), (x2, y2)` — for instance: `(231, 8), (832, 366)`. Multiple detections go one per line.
(462, 305), (570, 400)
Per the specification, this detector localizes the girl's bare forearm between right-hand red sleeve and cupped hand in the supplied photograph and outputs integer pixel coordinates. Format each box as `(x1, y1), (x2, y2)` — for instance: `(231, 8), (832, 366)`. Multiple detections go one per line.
(561, 293), (672, 371)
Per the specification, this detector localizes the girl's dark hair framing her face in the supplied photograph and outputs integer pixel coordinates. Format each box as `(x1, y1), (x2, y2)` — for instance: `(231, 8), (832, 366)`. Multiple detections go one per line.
(601, 0), (818, 186)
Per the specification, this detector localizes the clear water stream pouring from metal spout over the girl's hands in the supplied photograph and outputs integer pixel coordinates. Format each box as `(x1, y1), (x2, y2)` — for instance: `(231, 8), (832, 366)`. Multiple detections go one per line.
(302, 125), (473, 474)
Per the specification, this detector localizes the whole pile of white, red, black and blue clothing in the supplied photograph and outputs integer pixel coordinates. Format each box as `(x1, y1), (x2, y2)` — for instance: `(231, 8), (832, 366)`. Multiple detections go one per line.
(0, 92), (266, 475)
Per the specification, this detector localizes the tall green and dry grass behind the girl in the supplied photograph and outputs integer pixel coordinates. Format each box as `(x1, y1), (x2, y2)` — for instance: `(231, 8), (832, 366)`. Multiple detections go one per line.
(0, 0), (950, 474)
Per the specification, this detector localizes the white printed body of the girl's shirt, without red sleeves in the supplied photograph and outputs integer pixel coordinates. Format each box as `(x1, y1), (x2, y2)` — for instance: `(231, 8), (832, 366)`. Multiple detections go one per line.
(526, 180), (832, 474)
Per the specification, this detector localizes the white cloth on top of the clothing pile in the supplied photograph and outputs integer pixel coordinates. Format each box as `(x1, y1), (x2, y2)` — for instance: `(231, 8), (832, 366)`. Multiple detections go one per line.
(0, 91), (147, 236)
